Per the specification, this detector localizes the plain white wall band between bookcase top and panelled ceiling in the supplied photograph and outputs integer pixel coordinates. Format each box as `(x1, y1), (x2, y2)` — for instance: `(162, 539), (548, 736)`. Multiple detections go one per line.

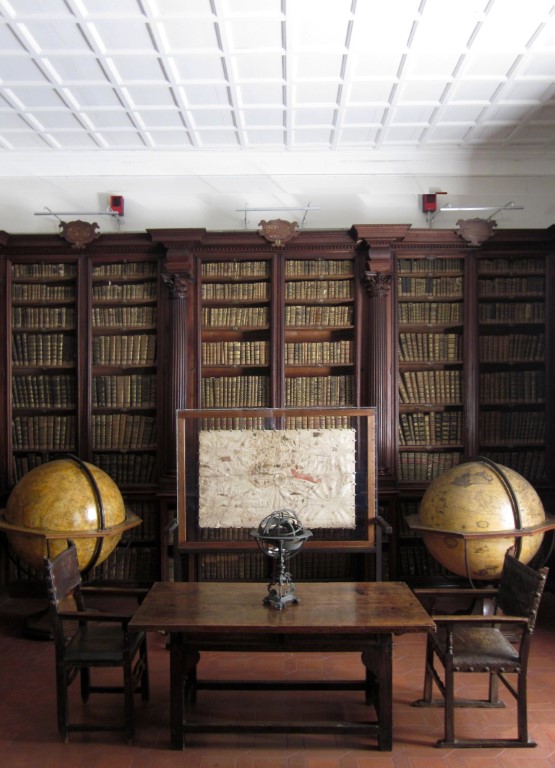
(0, 152), (555, 234)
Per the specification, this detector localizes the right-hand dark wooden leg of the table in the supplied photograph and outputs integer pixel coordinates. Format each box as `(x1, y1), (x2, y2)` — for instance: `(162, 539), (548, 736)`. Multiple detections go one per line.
(362, 634), (393, 752)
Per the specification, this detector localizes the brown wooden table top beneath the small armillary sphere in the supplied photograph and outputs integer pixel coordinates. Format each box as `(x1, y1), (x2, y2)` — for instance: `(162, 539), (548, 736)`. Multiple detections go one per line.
(129, 581), (435, 634)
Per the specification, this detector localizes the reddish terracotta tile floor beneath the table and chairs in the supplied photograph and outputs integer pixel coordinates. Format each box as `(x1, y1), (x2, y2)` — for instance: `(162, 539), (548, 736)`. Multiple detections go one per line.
(0, 593), (555, 768)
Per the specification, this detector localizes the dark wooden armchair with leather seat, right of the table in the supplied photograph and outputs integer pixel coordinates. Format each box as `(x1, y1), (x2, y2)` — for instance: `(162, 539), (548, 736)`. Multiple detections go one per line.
(414, 552), (549, 747)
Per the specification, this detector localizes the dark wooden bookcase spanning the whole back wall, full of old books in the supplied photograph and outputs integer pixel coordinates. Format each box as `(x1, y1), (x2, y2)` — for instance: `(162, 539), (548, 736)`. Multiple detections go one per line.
(0, 224), (555, 581)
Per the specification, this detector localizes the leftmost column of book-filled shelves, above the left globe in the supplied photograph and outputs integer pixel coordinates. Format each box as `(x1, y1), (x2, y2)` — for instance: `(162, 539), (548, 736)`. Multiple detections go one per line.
(9, 259), (79, 483)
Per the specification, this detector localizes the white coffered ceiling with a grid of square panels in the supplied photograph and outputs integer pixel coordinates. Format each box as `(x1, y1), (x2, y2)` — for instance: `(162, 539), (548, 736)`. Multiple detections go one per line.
(0, 0), (555, 158)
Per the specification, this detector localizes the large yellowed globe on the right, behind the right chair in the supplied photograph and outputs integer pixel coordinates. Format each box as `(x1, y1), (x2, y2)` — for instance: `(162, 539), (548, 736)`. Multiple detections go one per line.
(411, 457), (553, 580)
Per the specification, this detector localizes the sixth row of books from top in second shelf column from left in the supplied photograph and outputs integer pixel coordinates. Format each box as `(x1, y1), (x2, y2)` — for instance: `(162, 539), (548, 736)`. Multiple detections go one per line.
(92, 413), (156, 451)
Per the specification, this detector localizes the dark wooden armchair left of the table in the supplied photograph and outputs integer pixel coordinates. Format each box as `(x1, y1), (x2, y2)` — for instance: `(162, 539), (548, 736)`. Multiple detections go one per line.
(44, 542), (149, 743)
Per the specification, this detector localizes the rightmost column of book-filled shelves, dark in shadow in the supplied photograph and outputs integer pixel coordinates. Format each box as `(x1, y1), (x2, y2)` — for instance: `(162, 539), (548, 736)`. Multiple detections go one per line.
(478, 254), (549, 484)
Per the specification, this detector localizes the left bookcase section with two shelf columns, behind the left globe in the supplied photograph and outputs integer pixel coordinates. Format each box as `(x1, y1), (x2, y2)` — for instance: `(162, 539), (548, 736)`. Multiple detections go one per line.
(2, 236), (164, 582)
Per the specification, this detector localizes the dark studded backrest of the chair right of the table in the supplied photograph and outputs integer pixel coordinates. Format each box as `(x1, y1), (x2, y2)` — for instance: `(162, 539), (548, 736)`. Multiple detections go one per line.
(497, 552), (549, 632)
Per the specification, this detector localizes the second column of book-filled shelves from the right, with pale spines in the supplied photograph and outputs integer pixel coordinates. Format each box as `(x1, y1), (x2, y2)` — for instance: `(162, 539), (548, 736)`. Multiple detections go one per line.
(397, 255), (464, 484)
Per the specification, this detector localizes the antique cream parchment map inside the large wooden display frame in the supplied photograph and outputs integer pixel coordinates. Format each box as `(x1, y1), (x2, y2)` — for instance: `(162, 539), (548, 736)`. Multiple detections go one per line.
(199, 429), (355, 528)
